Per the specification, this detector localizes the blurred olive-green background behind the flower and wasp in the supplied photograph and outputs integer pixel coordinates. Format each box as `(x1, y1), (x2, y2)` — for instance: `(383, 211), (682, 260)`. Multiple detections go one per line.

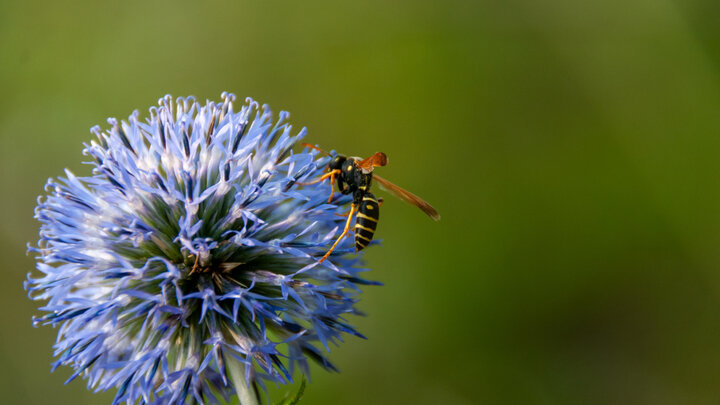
(0, 0), (720, 404)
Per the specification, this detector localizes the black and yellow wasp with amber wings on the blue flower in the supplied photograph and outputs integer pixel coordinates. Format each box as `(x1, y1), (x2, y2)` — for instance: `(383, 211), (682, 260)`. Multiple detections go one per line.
(299, 143), (440, 263)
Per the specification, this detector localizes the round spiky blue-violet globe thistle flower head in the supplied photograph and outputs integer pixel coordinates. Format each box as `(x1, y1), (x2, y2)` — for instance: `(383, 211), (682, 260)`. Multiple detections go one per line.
(25, 93), (374, 404)
